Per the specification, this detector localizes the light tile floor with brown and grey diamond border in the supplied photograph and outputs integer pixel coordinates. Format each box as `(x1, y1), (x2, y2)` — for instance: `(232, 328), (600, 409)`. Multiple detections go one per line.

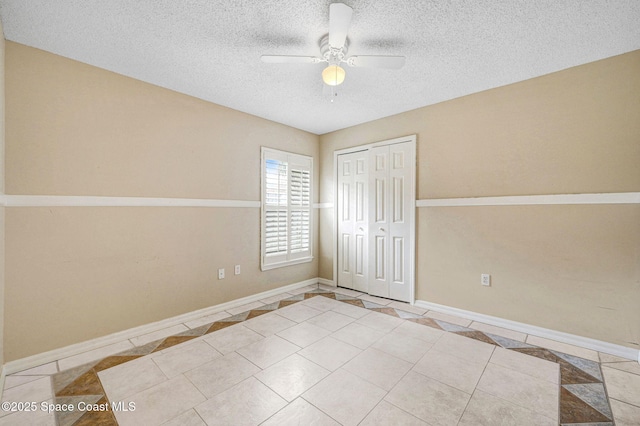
(0, 286), (640, 426)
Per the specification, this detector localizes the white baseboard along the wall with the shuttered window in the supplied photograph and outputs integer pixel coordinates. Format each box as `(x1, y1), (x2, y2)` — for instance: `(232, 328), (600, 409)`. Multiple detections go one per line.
(0, 278), (318, 376)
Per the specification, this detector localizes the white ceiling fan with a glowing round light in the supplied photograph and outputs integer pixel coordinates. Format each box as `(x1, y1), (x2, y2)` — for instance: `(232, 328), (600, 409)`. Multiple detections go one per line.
(260, 3), (405, 86)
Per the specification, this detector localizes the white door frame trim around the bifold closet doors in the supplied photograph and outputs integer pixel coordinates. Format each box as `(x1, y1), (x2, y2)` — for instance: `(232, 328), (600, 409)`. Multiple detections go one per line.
(331, 135), (418, 305)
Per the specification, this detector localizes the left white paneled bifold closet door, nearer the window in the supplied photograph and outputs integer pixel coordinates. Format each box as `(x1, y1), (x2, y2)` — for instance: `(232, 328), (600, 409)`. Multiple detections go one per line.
(338, 151), (369, 292)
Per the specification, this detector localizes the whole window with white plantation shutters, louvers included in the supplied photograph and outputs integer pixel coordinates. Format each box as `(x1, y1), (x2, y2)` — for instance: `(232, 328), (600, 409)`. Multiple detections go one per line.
(261, 148), (313, 271)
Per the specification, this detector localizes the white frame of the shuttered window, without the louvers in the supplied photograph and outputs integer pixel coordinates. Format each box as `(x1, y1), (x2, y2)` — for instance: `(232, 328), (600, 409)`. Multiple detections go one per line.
(260, 147), (314, 271)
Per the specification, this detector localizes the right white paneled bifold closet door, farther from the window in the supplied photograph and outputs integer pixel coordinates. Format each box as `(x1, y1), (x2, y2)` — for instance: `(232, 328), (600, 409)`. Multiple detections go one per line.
(368, 143), (415, 302)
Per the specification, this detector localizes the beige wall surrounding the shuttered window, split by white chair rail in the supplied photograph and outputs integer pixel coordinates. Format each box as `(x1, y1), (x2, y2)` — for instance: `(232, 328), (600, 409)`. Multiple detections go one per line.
(4, 42), (319, 361)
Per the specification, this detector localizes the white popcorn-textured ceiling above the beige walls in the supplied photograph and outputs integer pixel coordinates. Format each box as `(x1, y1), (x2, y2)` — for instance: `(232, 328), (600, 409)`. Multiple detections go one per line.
(0, 0), (640, 134)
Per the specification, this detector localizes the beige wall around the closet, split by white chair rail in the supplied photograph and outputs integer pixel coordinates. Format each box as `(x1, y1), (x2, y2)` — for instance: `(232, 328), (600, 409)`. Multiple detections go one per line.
(319, 51), (640, 349)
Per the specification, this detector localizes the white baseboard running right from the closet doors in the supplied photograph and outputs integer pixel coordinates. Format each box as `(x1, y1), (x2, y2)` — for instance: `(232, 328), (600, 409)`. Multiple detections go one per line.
(415, 300), (640, 362)
